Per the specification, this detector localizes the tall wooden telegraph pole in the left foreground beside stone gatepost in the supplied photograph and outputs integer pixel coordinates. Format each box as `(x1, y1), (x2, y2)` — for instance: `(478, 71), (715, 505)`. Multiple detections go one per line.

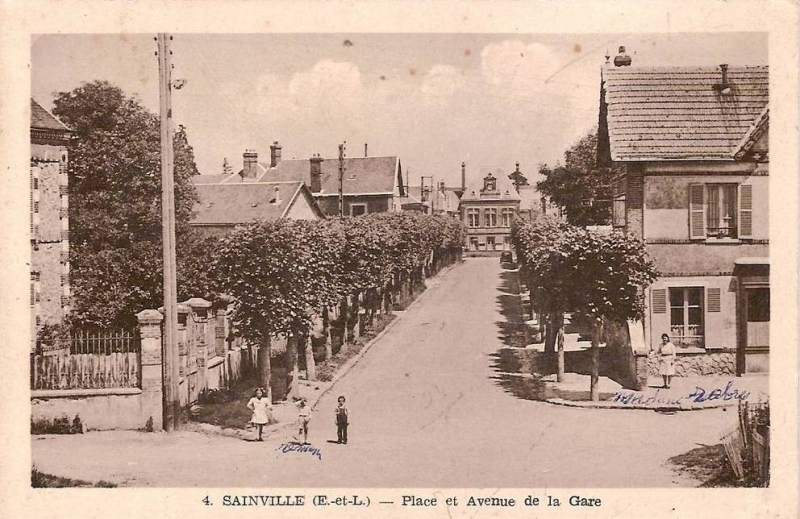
(156, 33), (180, 432)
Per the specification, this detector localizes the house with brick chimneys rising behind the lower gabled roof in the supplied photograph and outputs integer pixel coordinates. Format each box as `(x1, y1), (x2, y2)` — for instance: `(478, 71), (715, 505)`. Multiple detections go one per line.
(195, 142), (404, 216)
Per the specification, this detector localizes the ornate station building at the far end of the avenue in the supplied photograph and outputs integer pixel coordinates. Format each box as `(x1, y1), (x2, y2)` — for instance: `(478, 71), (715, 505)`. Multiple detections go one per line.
(459, 173), (520, 251)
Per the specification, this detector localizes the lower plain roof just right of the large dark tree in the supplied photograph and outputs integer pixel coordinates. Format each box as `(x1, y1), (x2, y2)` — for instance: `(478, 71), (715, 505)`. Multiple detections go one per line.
(192, 182), (303, 225)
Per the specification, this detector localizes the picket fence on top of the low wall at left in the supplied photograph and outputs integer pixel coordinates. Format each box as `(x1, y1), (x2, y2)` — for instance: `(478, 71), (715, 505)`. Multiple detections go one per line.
(31, 330), (141, 389)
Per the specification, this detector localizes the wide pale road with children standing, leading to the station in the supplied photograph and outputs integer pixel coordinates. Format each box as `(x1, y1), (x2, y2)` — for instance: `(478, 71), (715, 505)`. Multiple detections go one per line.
(33, 258), (735, 488)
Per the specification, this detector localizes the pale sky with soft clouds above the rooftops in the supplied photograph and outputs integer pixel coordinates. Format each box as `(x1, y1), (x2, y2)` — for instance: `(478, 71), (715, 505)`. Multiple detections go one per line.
(31, 33), (767, 186)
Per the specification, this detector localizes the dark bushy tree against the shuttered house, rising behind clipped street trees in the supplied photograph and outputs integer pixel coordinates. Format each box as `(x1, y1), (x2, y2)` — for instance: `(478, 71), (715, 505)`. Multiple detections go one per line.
(536, 129), (613, 226)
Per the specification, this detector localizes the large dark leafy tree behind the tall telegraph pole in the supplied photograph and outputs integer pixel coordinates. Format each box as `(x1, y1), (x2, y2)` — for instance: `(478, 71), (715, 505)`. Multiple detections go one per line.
(53, 81), (197, 326)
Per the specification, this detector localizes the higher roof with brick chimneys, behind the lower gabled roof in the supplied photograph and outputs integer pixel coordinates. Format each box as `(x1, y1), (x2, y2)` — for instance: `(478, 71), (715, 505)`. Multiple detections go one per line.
(230, 157), (398, 196)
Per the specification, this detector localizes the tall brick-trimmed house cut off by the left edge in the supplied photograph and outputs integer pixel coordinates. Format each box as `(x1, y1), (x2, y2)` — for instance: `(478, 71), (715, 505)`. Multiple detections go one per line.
(30, 99), (72, 346)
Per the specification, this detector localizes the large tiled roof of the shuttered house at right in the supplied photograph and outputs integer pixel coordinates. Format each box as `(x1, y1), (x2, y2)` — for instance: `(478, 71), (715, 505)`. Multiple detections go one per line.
(601, 66), (769, 161)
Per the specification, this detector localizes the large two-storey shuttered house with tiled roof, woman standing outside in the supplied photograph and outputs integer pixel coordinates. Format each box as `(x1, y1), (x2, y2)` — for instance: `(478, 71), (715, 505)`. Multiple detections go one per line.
(598, 60), (770, 374)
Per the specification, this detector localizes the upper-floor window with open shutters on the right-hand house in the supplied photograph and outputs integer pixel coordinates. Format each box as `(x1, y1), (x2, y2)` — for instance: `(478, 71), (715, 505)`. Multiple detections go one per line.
(689, 183), (753, 240)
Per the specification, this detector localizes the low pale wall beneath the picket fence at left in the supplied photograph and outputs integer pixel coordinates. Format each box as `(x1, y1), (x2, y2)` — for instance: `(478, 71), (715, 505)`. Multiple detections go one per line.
(31, 388), (155, 430)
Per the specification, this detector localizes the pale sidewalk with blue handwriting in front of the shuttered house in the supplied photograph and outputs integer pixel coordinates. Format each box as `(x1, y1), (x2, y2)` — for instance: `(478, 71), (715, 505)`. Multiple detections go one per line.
(544, 373), (769, 411)
